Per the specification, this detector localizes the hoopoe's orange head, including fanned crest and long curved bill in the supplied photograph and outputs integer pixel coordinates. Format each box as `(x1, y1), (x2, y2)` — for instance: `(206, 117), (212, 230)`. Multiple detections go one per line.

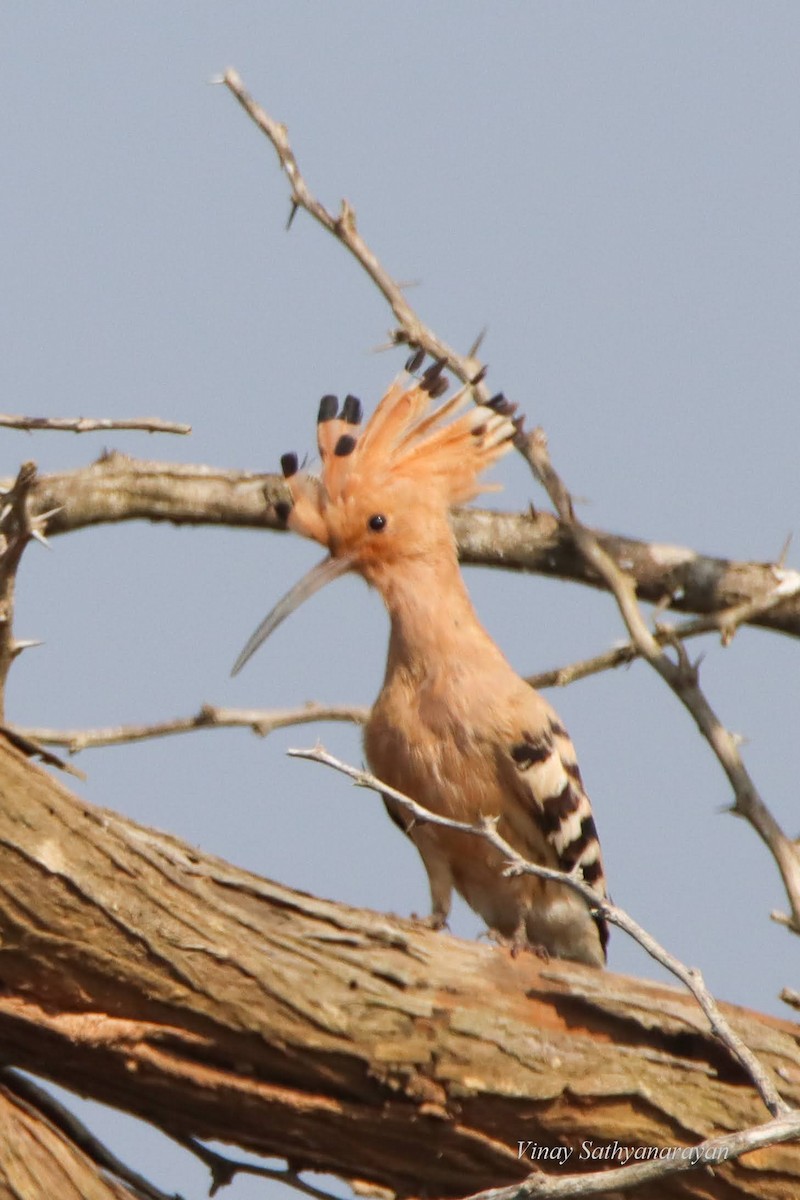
(233, 365), (519, 674)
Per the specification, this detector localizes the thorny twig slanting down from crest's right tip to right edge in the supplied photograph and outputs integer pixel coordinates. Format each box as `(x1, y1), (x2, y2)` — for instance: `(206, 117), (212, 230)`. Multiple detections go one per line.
(518, 430), (800, 934)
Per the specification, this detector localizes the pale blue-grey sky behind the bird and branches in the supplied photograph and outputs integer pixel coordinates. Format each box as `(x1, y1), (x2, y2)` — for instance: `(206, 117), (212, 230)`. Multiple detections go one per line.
(0, 0), (800, 1200)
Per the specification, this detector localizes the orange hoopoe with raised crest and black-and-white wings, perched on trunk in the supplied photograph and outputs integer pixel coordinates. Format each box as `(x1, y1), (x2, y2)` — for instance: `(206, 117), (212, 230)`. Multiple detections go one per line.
(234, 354), (608, 966)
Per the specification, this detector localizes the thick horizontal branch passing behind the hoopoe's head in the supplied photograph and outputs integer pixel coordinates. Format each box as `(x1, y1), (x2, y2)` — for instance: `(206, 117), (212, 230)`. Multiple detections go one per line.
(10, 454), (800, 637)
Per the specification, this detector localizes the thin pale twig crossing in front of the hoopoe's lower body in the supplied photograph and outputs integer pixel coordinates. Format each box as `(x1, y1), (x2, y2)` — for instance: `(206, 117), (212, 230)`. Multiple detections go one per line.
(287, 744), (794, 1116)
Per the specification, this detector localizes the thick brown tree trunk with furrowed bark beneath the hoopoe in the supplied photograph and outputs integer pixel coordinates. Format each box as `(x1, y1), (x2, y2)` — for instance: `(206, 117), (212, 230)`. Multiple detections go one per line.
(0, 743), (800, 1200)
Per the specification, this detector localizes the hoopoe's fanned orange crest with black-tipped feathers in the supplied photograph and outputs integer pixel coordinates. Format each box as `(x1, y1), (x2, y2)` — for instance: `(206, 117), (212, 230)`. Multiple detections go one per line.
(281, 362), (521, 546)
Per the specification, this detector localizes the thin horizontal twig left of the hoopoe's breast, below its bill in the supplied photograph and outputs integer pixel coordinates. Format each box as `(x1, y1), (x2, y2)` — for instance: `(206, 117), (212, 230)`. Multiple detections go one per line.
(13, 701), (369, 755)
